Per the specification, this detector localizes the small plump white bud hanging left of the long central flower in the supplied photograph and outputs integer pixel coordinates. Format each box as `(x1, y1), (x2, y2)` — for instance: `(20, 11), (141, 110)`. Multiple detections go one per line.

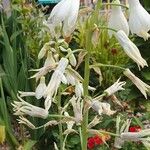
(35, 76), (46, 99)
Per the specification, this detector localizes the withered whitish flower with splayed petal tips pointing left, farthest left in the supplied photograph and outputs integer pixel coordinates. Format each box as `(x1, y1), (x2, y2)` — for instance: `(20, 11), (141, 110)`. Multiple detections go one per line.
(12, 96), (48, 119)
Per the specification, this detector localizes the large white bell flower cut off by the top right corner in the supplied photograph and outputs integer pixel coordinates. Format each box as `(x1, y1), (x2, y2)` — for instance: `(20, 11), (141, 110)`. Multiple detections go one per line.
(128, 0), (150, 40)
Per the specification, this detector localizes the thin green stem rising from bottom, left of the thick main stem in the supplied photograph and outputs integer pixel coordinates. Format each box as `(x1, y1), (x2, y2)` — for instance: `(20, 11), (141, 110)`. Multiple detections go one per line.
(57, 89), (63, 150)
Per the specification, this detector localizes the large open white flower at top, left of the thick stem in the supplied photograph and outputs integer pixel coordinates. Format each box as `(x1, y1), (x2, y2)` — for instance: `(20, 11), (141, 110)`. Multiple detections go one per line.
(48, 0), (80, 37)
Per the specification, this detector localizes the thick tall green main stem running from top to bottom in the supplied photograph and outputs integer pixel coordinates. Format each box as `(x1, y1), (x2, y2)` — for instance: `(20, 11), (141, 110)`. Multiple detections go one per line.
(81, 0), (102, 150)
